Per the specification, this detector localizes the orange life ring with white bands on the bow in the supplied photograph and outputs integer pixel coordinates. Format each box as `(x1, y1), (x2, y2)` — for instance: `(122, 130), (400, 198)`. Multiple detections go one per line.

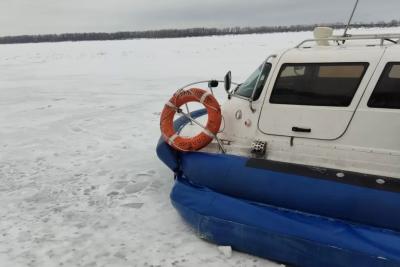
(160, 88), (222, 151)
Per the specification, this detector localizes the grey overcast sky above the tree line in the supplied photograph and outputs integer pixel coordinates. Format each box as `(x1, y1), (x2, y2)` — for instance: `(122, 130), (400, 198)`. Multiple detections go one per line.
(0, 0), (400, 36)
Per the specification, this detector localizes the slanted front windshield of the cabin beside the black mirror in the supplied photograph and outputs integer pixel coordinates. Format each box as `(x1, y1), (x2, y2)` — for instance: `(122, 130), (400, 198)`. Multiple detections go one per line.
(235, 63), (271, 100)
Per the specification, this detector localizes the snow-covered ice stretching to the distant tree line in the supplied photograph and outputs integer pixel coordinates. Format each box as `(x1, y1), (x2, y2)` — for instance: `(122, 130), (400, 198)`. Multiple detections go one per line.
(0, 29), (396, 267)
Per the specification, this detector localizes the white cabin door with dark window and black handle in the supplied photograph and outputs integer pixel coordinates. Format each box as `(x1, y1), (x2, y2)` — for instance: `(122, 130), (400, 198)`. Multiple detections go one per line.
(258, 47), (383, 140)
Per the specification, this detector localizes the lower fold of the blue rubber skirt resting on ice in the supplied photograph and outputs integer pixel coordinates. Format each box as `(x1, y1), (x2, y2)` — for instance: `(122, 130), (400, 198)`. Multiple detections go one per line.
(171, 179), (400, 266)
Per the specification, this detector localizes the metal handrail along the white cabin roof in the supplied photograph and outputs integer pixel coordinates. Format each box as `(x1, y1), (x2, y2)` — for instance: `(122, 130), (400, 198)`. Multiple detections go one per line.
(295, 33), (400, 48)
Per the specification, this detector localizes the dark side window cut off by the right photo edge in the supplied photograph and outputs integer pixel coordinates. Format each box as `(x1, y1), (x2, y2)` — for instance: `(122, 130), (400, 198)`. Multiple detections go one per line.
(368, 63), (400, 109)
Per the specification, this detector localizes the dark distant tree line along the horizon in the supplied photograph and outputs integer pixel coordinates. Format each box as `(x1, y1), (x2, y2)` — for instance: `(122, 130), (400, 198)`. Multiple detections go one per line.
(0, 20), (400, 44)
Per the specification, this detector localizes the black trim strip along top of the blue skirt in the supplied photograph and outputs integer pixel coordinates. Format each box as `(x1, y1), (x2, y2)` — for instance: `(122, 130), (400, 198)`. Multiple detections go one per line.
(246, 159), (400, 193)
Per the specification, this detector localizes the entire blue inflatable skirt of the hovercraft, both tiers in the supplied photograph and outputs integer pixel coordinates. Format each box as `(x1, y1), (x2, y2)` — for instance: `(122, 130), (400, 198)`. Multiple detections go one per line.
(157, 110), (400, 266)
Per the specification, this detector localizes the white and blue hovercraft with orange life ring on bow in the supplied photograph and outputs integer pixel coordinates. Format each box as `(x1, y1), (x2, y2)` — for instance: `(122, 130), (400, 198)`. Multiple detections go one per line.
(157, 28), (400, 266)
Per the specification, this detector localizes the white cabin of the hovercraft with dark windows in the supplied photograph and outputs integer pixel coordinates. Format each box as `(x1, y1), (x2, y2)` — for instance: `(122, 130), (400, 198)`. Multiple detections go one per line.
(219, 29), (400, 182)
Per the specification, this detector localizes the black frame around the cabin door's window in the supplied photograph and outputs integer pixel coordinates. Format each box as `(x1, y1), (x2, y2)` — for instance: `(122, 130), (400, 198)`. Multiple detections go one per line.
(268, 61), (370, 108)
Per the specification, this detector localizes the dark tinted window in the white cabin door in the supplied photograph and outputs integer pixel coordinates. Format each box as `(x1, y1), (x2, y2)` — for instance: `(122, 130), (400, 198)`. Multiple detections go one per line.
(270, 63), (368, 107)
